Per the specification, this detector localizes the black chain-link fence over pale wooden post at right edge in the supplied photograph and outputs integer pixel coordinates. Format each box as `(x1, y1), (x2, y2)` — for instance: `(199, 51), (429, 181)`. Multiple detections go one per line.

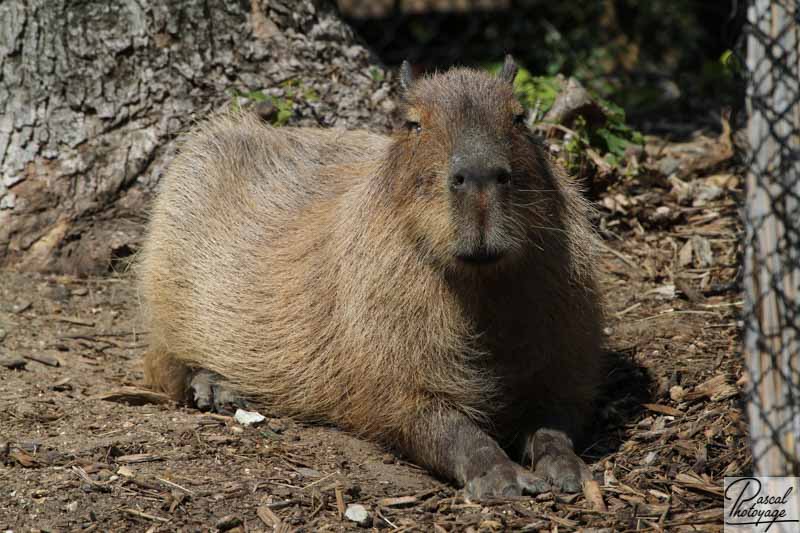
(745, 0), (800, 476)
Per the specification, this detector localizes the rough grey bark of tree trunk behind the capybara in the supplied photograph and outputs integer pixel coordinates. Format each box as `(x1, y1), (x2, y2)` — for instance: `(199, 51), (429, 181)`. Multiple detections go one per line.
(0, 0), (392, 274)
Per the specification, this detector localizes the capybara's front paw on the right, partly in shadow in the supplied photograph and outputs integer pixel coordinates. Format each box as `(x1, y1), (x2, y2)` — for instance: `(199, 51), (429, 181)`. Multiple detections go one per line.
(529, 429), (592, 492)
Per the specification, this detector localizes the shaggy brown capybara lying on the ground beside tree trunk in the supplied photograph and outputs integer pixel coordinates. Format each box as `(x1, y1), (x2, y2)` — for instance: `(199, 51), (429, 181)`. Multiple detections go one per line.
(139, 57), (605, 498)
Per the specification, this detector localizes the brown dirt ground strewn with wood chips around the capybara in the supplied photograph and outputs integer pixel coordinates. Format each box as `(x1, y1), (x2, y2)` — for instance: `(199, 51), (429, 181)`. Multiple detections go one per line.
(0, 127), (750, 532)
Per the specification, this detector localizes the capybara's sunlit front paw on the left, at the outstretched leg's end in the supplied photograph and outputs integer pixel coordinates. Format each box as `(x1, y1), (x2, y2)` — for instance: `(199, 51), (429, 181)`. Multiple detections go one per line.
(464, 461), (550, 500)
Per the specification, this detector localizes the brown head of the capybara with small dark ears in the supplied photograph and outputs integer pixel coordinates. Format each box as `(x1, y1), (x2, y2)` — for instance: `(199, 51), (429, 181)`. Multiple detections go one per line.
(383, 56), (558, 272)
